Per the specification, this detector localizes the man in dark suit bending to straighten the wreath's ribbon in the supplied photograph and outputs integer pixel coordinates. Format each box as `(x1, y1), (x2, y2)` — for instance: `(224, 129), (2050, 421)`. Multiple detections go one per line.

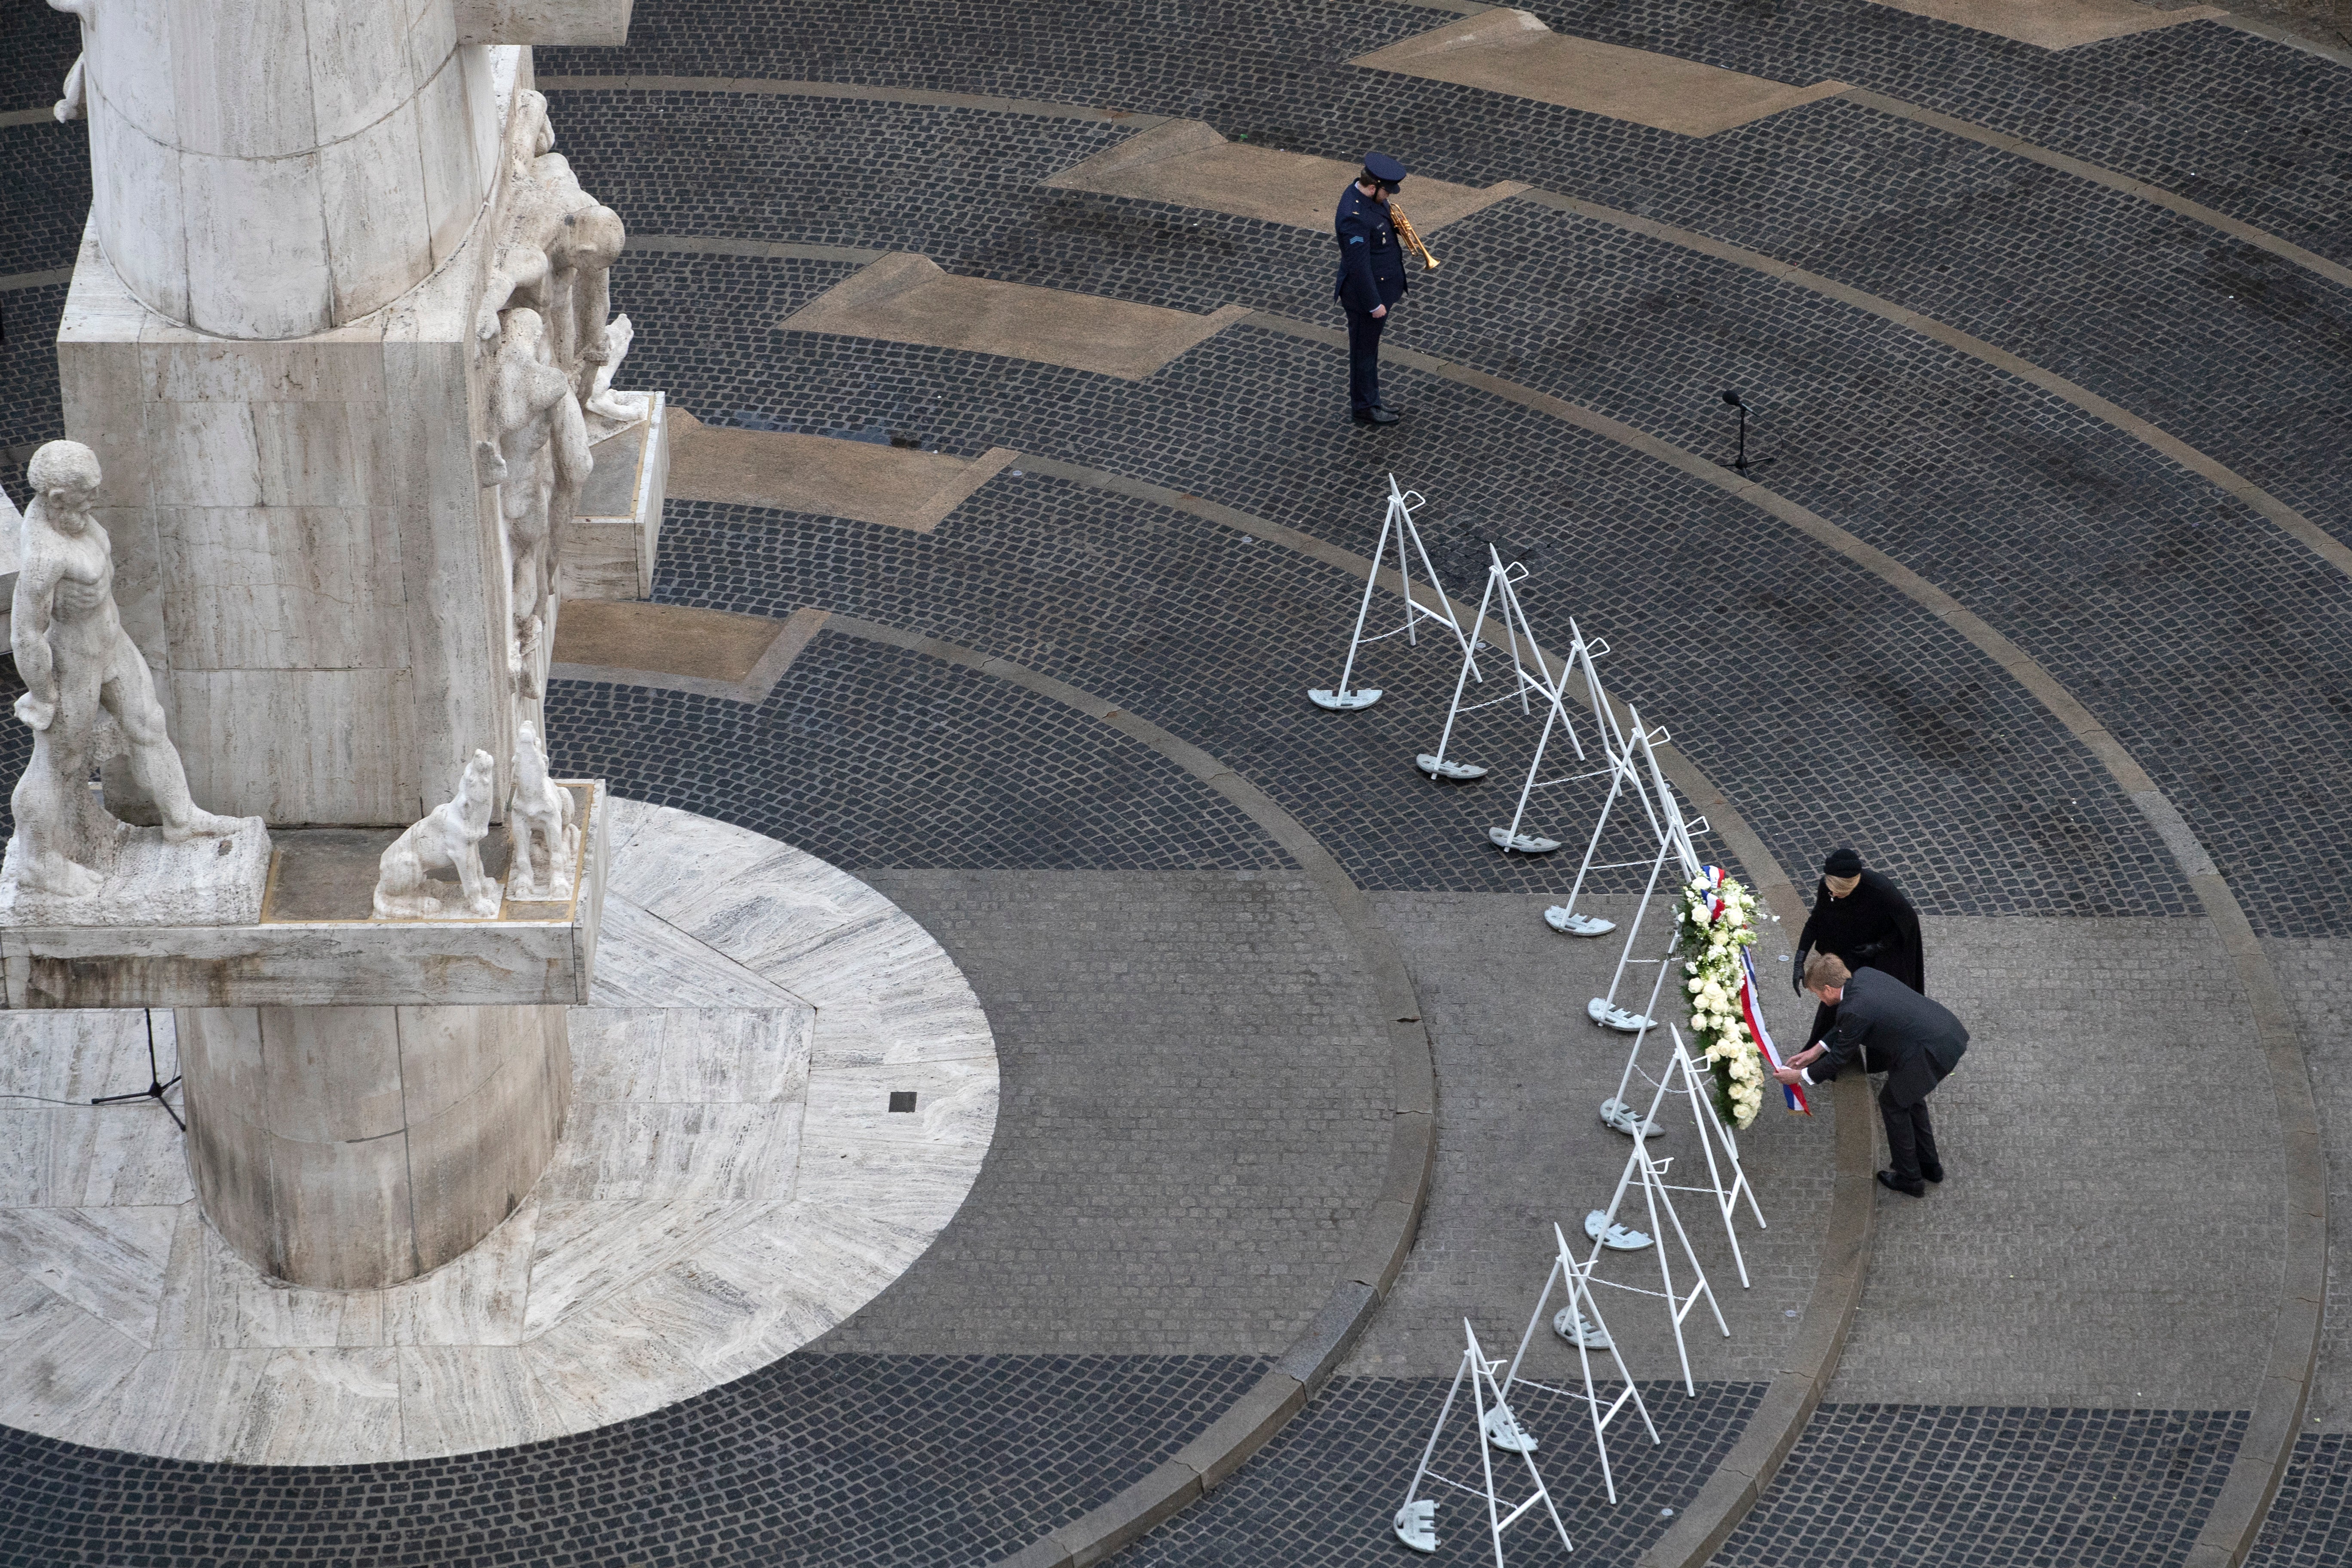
(1773, 952), (1969, 1199)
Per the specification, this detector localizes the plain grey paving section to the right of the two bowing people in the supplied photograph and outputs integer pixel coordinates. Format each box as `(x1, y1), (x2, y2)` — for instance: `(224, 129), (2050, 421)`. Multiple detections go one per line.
(1828, 917), (2282, 1411)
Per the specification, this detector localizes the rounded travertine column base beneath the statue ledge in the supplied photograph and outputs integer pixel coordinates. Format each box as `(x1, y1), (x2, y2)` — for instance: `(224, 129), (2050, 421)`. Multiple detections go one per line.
(176, 1006), (572, 1291)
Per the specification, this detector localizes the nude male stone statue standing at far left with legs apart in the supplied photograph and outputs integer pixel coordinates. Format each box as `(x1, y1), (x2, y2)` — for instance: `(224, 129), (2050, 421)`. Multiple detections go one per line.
(7, 442), (242, 898)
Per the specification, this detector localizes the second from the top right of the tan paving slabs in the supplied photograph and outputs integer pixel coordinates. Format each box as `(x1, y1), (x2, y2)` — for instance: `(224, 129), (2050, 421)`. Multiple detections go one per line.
(1350, 11), (1844, 136)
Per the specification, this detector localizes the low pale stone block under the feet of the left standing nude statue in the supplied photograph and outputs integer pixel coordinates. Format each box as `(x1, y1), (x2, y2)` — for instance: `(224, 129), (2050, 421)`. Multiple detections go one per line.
(0, 816), (270, 926)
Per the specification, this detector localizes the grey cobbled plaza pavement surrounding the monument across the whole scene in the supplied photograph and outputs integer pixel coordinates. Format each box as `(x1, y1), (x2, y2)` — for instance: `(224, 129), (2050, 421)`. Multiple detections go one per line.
(0, 0), (2352, 1568)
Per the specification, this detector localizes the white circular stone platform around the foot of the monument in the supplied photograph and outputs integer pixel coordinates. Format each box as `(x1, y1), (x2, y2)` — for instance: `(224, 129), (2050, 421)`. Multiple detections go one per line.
(0, 799), (997, 1464)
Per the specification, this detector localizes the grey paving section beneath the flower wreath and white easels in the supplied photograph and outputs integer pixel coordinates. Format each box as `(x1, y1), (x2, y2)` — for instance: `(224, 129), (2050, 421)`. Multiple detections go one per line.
(1343, 893), (1834, 1401)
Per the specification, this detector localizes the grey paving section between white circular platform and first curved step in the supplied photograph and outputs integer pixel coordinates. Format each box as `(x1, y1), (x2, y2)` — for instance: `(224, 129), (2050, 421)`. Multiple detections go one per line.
(821, 870), (1390, 1357)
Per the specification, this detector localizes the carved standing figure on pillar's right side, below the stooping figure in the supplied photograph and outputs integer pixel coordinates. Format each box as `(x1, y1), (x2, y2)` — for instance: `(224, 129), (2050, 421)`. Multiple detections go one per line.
(478, 308), (595, 696)
